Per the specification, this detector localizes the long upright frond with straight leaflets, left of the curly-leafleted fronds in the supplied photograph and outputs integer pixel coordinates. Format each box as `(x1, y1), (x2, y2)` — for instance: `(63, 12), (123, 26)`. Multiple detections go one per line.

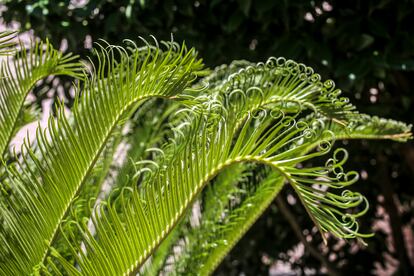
(0, 38), (202, 274)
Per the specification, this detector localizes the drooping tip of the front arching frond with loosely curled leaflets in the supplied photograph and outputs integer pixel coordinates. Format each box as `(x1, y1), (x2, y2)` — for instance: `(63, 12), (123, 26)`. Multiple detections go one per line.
(286, 149), (372, 244)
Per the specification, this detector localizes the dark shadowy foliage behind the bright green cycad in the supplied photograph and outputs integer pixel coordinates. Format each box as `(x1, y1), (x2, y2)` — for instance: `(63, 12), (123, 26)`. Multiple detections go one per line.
(2, 0), (414, 275)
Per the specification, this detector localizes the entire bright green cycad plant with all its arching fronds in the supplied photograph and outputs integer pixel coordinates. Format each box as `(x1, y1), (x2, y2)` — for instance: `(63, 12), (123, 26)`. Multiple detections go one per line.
(0, 28), (411, 275)
